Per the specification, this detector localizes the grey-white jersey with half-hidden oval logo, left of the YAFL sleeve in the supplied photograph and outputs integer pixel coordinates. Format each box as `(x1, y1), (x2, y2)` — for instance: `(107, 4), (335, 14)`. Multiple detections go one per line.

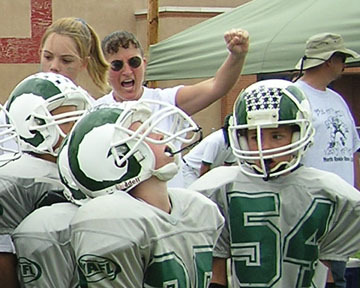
(13, 203), (78, 288)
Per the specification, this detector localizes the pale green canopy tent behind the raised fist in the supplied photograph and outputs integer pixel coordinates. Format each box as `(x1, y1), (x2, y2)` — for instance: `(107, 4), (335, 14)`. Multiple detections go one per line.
(146, 0), (360, 80)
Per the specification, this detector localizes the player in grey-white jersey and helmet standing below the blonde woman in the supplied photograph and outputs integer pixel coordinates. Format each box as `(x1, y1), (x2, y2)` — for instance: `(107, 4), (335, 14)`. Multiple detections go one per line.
(0, 72), (90, 287)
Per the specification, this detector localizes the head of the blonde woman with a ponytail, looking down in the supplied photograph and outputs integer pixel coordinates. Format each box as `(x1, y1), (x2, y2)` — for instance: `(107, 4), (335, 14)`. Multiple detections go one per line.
(40, 17), (109, 92)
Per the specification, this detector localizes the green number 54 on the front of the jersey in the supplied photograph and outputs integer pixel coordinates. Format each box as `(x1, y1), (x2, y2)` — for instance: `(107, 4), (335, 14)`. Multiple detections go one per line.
(229, 192), (334, 287)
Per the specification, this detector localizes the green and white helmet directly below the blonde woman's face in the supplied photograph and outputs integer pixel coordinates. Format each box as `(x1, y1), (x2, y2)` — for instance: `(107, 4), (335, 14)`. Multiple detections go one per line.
(6, 72), (91, 156)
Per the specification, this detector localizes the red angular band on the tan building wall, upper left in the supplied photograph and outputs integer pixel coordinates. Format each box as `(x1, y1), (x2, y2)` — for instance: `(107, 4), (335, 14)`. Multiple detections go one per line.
(0, 0), (52, 63)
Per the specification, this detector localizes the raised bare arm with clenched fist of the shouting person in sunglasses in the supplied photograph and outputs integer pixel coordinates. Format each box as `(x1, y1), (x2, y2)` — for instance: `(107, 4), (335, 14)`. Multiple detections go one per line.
(176, 29), (249, 115)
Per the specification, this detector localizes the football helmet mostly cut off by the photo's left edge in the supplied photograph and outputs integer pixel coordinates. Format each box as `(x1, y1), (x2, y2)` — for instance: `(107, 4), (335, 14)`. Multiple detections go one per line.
(0, 104), (21, 166)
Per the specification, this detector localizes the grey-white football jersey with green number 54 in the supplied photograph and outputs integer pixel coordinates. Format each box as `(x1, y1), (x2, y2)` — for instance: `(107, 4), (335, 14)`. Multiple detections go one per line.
(190, 166), (360, 288)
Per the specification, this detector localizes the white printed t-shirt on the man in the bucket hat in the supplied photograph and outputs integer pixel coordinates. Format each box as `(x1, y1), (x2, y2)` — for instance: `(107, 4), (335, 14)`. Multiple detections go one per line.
(295, 80), (360, 185)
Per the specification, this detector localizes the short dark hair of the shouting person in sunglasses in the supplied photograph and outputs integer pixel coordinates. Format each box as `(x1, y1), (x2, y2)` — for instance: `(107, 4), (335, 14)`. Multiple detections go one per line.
(101, 31), (144, 56)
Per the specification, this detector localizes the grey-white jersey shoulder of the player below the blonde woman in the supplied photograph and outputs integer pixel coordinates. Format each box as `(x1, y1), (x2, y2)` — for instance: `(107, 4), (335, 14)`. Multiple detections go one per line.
(0, 153), (61, 234)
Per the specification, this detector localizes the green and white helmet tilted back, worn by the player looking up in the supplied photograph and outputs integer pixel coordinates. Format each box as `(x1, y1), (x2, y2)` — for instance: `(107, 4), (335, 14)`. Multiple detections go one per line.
(68, 100), (200, 198)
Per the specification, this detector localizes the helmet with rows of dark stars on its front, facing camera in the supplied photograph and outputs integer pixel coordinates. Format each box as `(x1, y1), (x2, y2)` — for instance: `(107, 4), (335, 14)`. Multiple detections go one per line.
(229, 79), (314, 179)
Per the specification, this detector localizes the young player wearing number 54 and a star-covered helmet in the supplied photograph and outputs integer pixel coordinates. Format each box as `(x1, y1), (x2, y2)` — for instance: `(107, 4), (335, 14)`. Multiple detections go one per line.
(190, 80), (360, 288)
